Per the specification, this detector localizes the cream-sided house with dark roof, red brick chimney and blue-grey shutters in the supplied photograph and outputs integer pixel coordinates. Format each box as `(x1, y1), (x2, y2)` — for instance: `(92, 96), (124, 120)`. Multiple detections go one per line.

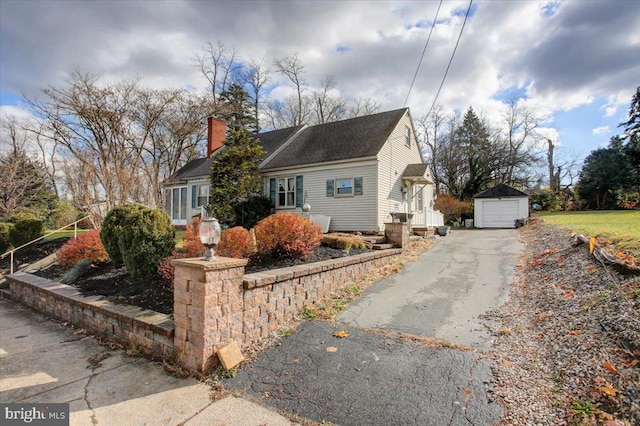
(164, 108), (433, 233)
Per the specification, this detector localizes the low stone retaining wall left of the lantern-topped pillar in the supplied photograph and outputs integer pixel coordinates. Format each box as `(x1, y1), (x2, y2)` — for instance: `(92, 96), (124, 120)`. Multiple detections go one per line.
(7, 272), (175, 359)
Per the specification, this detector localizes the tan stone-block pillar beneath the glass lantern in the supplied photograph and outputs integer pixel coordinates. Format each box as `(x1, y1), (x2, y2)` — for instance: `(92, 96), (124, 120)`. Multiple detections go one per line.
(171, 257), (247, 372)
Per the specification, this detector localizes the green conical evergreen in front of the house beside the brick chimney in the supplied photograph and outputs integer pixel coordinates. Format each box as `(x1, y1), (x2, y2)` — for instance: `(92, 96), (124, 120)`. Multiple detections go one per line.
(210, 127), (264, 226)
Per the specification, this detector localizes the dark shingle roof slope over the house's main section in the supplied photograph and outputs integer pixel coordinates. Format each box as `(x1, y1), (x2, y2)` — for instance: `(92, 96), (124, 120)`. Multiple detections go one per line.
(263, 108), (407, 170)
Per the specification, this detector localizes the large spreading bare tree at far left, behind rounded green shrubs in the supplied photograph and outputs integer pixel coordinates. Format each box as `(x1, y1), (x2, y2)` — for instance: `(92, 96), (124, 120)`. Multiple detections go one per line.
(28, 71), (145, 220)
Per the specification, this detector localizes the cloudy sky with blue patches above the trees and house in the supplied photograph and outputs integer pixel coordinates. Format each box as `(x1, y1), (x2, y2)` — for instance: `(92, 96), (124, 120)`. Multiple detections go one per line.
(0, 0), (640, 163)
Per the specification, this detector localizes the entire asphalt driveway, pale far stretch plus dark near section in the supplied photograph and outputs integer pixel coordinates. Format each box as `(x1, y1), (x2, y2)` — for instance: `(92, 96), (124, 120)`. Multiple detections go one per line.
(224, 230), (524, 426)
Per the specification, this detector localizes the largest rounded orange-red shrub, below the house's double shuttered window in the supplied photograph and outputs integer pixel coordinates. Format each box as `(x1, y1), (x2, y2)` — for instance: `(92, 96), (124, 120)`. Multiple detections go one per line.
(254, 212), (322, 259)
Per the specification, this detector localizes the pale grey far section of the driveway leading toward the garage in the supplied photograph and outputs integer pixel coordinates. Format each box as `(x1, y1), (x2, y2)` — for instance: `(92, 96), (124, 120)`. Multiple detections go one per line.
(338, 229), (524, 348)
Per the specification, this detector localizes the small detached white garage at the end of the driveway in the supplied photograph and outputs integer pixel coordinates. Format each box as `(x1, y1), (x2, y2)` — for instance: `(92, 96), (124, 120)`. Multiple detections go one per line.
(473, 183), (529, 228)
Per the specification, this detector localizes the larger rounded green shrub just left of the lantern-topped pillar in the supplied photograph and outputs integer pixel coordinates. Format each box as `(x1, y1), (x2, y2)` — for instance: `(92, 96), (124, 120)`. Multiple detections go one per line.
(117, 207), (175, 278)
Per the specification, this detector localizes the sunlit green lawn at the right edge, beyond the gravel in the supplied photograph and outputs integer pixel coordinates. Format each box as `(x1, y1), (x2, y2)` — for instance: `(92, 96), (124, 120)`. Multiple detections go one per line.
(535, 210), (640, 259)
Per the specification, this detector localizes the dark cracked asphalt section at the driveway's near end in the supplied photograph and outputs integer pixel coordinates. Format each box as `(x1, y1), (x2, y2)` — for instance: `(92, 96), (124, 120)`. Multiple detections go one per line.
(224, 321), (502, 426)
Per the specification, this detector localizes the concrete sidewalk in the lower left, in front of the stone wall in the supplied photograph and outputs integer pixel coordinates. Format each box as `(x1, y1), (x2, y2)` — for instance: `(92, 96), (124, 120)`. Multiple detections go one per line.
(0, 299), (293, 426)
